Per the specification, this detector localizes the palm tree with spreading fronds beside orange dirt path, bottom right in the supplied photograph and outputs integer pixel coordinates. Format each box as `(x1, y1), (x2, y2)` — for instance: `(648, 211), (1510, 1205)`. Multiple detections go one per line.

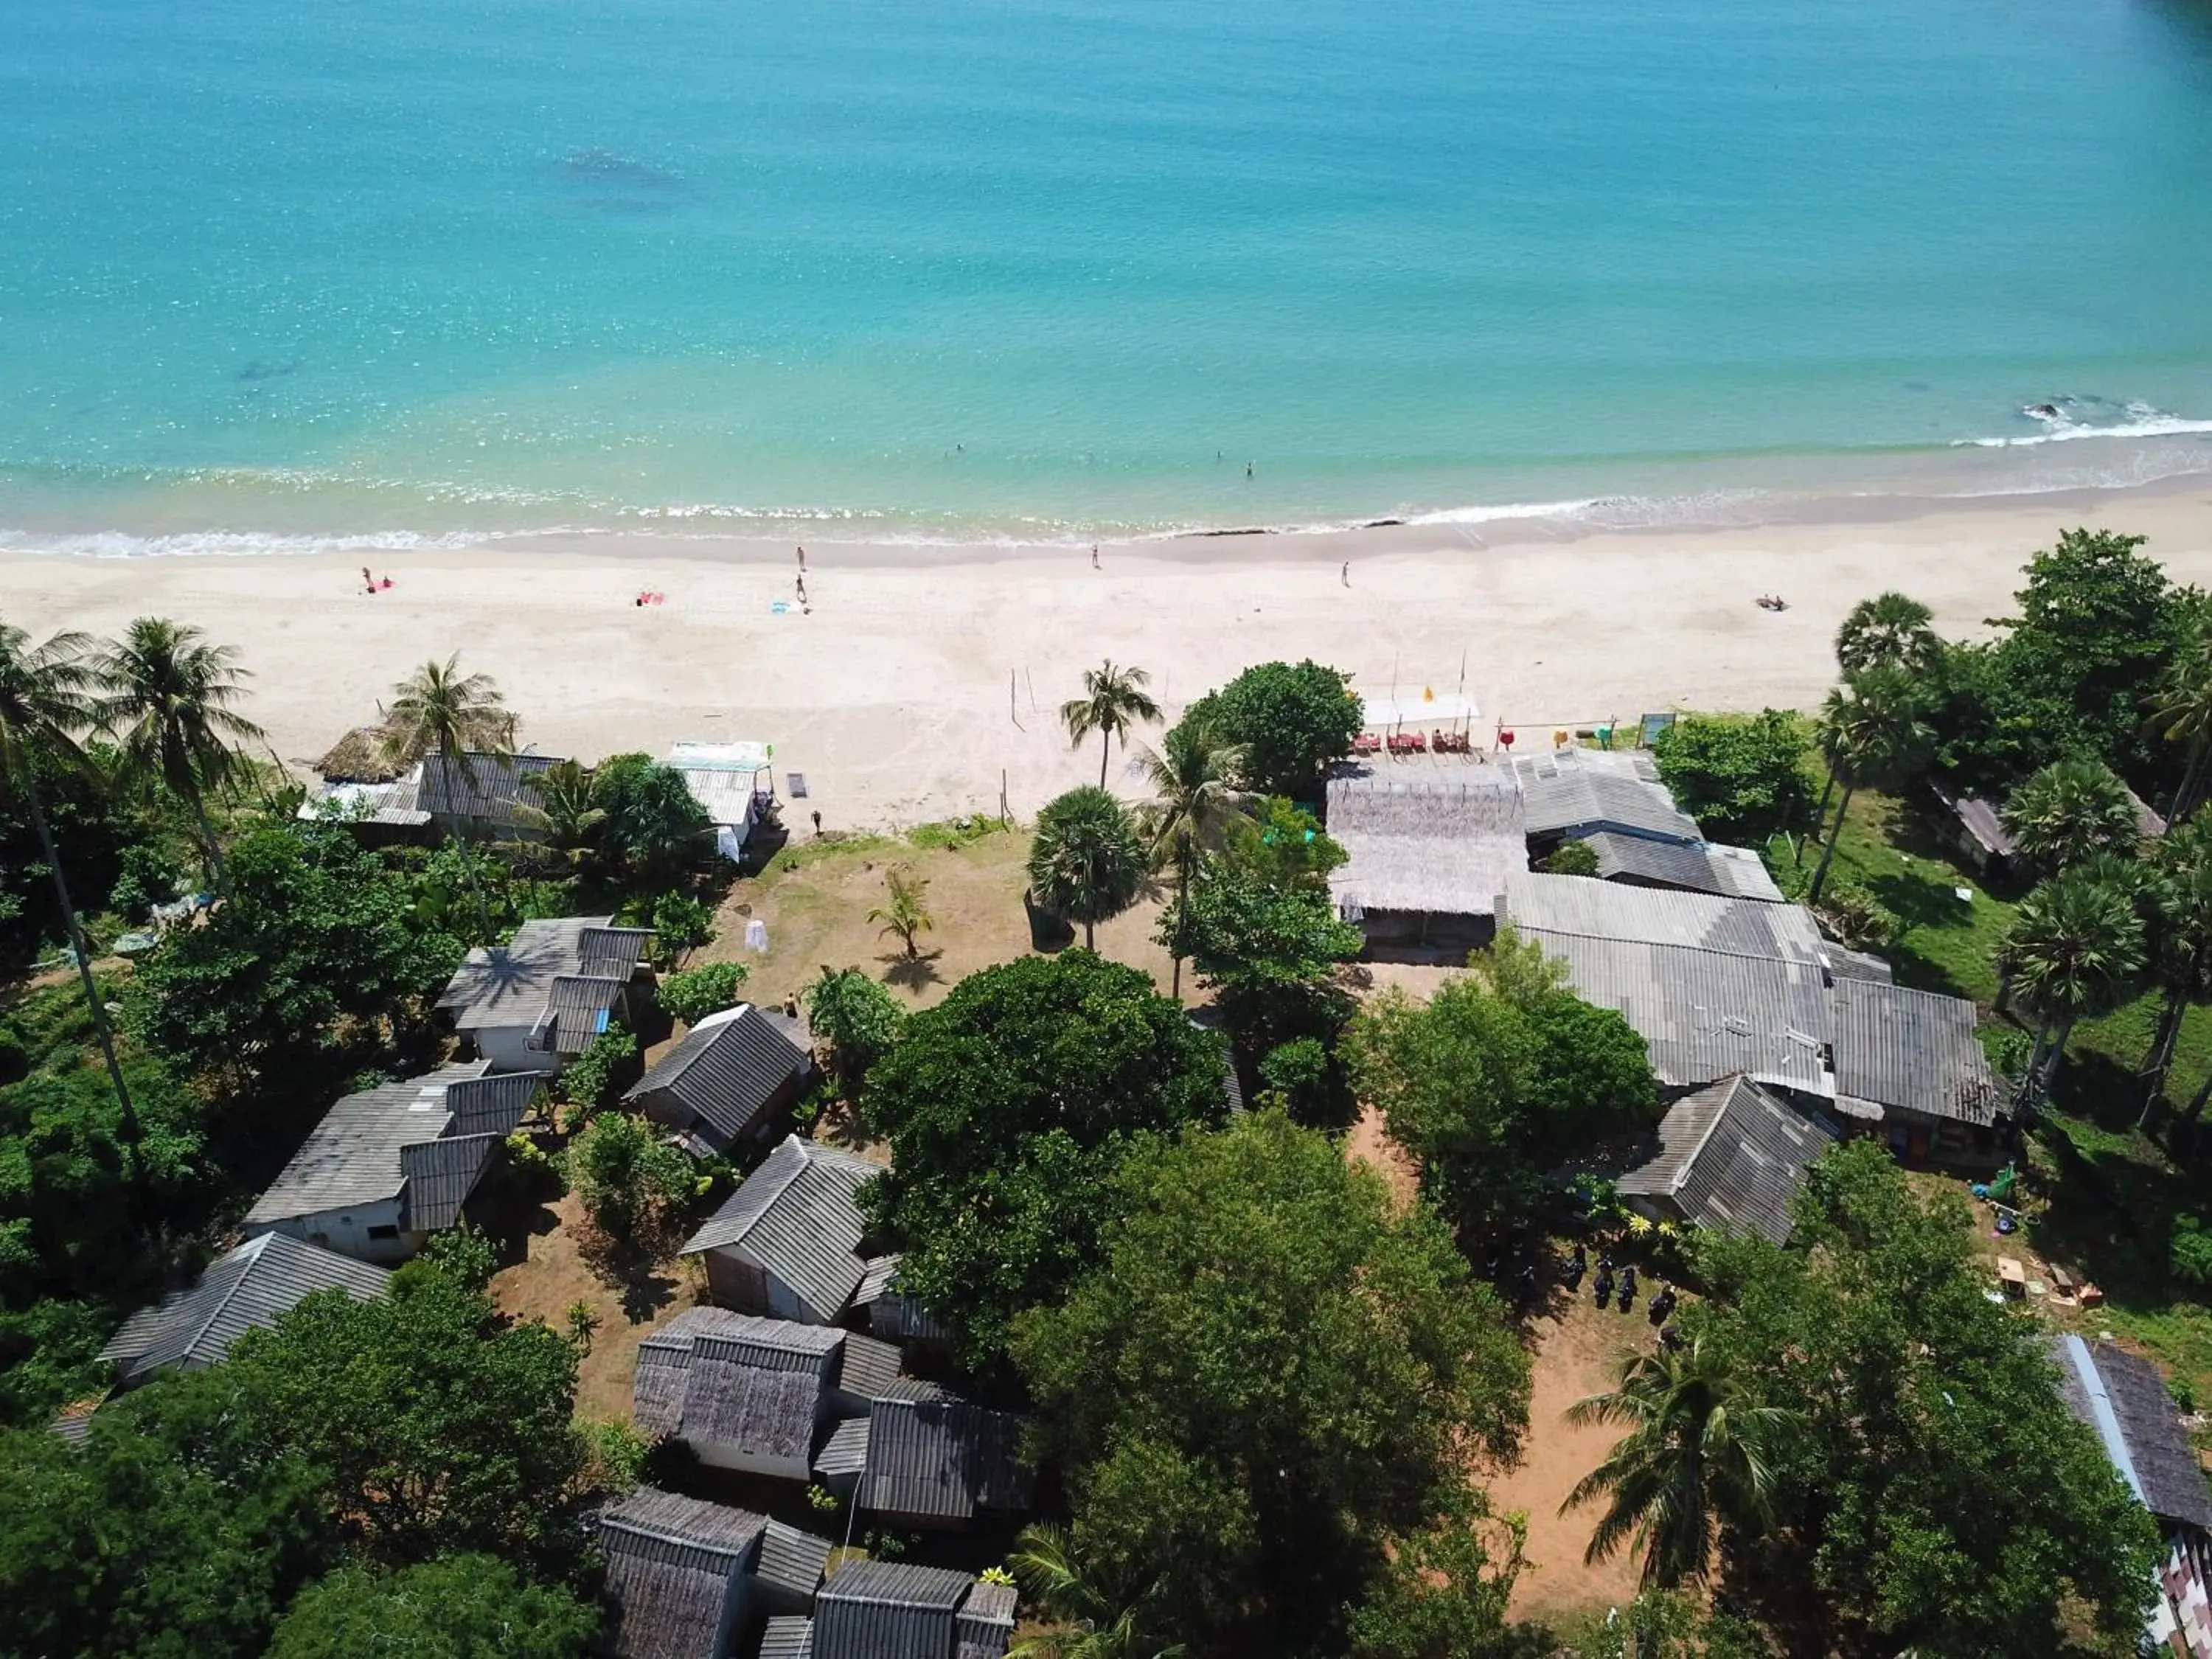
(1559, 1336), (1794, 1588)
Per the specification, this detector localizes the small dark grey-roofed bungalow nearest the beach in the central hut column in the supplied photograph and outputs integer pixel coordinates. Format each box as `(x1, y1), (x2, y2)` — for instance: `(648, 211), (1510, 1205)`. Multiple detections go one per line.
(622, 1002), (814, 1157)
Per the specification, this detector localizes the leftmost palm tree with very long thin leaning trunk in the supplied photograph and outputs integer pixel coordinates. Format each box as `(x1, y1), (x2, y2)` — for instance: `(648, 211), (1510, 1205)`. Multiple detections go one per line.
(0, 622), (146, 1214)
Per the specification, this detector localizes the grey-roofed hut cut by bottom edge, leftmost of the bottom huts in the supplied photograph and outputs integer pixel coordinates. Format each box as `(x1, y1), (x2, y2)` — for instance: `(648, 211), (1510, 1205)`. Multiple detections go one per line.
(595, 1486), (832, 1659)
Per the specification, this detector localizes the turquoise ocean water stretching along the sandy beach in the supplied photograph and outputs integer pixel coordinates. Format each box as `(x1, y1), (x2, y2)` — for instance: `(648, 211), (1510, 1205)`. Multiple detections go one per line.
(0, 0), (2212, 553)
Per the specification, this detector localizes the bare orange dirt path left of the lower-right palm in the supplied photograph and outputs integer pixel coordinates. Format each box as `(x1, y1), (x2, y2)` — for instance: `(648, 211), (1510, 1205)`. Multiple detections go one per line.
(1489, 1290), (1652, 1619)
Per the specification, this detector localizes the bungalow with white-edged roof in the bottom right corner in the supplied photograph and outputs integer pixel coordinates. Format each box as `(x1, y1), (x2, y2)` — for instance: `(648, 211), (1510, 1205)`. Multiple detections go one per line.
(2051, 1334), (2212, 1659)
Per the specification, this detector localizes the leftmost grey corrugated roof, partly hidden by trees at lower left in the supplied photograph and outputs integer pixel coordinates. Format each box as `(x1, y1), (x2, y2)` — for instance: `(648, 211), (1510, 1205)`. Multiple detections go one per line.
(100, 1232), (392, 1387)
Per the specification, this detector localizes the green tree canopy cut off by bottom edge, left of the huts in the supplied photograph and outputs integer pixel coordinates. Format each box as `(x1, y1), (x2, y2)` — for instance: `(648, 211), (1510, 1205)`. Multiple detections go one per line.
(268, 1555), (599, 1659)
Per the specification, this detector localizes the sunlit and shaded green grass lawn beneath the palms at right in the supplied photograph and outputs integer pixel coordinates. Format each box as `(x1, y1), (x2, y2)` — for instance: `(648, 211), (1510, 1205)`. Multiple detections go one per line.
(1767, 792), (2212, 1402)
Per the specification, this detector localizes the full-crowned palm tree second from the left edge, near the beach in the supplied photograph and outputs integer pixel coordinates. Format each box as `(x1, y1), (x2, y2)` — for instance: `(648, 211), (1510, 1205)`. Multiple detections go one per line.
(93, 617), (265, 894)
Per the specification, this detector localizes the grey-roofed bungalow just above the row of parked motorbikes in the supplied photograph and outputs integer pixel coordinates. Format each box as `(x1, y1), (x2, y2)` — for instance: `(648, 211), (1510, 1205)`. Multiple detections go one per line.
(1613, 1075), (1836, 1243)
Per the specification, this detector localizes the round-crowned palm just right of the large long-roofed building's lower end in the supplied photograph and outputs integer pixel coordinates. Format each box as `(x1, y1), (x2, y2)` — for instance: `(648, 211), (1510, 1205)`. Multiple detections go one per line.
(1997, 860), (2143, 1104)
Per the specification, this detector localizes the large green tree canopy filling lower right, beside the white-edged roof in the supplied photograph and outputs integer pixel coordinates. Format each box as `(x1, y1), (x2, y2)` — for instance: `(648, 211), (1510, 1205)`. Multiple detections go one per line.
(1692, 1141), (2161, 1659)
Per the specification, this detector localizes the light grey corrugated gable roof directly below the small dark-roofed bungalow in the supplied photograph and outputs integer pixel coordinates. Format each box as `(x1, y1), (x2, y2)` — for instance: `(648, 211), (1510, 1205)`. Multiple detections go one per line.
(684, 1135), (883, 1321)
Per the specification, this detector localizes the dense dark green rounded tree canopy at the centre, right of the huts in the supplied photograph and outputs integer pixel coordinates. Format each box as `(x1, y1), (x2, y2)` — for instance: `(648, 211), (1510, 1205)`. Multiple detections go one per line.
(860, 949), (1225, 1367)
